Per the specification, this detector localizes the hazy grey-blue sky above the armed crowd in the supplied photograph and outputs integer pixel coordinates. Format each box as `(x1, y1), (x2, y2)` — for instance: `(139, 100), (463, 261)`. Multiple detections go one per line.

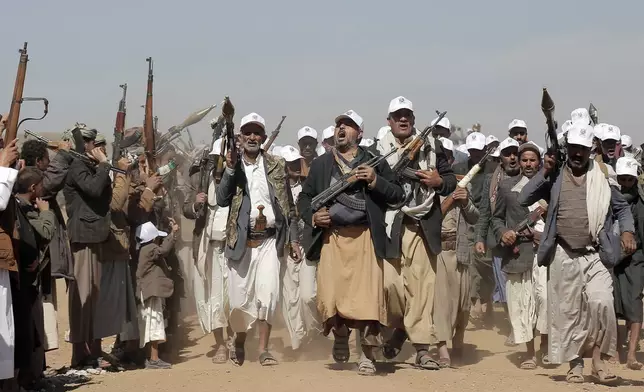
(0, 0), (644, 149)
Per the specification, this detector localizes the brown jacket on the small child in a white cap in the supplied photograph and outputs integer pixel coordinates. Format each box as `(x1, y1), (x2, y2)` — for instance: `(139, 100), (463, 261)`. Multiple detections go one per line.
(136, 233), (176, 301)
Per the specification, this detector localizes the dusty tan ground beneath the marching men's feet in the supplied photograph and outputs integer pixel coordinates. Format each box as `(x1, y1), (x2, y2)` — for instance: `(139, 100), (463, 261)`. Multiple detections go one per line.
(47, 285), (644, 392)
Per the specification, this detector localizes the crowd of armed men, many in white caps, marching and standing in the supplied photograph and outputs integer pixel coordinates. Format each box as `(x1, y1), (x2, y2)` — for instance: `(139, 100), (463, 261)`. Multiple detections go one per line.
(0, 97), (644, 390)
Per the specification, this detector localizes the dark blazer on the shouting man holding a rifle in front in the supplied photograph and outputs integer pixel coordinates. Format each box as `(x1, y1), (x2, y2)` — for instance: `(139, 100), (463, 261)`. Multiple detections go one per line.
(297, 147), (402, 260)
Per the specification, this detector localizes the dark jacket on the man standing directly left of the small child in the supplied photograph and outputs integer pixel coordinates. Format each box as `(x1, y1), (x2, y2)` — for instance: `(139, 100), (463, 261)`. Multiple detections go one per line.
(63, 159), (112, 244)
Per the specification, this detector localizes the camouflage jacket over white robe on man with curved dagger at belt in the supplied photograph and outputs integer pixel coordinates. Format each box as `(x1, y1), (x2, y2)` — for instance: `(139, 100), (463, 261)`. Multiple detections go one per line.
(217, 152), (298, 261)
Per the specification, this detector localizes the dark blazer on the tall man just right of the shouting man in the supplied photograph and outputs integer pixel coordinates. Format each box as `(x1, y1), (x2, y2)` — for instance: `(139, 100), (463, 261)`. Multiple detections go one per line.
(387, 140), (457, 258)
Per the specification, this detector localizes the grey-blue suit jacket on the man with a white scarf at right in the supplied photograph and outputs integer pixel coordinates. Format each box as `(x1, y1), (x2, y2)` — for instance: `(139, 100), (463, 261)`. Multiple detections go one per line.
(518, 160), (635, 267)
